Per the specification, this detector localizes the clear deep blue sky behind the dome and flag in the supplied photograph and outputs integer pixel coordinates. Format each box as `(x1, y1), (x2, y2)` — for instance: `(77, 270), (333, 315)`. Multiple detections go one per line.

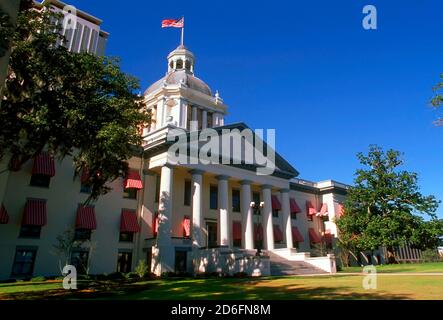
(70, 0), (443, 217)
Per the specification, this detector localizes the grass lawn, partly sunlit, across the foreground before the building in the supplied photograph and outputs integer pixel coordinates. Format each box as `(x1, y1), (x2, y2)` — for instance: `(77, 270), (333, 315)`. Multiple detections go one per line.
(0, 275), (443, 300)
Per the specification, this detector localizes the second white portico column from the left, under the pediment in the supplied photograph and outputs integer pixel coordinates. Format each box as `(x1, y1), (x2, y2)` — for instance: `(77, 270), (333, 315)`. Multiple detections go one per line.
(190, 170), (203, 248)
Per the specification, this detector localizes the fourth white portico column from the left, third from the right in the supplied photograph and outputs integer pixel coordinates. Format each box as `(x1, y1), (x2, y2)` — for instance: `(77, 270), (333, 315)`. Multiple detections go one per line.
(240, 180), (254, 250)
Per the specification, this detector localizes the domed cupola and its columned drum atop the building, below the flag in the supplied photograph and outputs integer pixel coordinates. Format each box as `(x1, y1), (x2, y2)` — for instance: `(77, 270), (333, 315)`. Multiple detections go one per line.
(143, 44), (227, 136)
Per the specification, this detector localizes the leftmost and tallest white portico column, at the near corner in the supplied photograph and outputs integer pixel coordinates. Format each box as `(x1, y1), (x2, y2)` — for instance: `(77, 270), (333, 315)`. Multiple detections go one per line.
(153, 164), (175, 275)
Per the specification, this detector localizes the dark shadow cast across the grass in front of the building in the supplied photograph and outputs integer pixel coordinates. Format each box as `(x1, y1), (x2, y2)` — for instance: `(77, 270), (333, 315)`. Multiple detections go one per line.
(0, 277), (410, 300)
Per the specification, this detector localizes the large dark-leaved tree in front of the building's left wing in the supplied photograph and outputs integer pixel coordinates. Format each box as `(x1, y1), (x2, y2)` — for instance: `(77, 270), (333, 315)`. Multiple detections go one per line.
(0, 1), (149, 199)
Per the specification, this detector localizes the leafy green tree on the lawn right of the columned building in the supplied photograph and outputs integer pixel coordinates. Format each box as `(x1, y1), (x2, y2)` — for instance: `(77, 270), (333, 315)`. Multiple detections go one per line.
(337, 145), (443, 263)
